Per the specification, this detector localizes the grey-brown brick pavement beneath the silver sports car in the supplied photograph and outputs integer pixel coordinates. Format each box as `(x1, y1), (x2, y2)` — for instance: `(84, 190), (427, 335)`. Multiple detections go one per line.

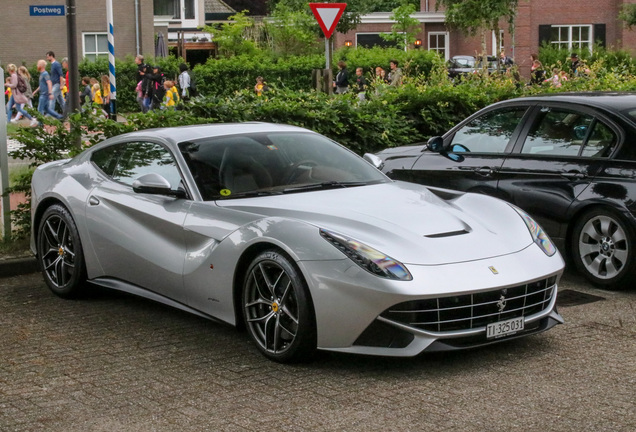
(0, 274), (636, 432)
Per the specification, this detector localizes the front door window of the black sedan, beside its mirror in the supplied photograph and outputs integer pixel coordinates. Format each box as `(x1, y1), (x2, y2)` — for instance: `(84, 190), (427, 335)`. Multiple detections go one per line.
(451, 107), (527, 153)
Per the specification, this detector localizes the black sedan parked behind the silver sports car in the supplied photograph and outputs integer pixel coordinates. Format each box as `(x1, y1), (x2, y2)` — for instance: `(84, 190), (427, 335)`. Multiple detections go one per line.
(366, 93), (636, 289)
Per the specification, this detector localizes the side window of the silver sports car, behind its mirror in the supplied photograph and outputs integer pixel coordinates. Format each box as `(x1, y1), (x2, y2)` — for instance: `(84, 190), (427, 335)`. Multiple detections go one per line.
(112, 142), (181, 189)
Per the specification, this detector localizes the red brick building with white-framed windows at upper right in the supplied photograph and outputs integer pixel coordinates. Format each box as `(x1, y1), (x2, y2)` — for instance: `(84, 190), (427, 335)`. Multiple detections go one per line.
(334, 0), (636, 75)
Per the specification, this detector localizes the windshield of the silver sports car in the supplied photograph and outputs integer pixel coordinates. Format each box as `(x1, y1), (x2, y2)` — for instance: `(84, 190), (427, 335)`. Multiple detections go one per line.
(179, 132), (390, 201)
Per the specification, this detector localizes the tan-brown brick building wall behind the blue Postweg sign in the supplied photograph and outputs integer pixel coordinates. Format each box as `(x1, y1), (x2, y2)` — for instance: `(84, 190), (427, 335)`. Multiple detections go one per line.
(0, 0), (155, 66)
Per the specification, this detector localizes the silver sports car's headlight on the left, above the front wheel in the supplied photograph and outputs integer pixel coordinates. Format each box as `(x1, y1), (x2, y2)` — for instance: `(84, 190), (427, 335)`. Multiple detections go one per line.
(320, 229), (413, 280)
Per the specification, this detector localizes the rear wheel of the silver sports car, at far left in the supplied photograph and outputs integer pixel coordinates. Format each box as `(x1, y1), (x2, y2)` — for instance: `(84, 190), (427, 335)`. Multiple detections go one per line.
(37, 204), (86, 298)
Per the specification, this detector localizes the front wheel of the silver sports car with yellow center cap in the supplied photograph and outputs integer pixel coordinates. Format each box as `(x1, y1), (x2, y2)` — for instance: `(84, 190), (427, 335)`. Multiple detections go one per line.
(241, 250), (316, 363)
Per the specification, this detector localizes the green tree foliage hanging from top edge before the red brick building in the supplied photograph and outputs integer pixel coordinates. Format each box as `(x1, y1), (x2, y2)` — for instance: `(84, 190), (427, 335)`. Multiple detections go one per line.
(435, 0), (519, 62)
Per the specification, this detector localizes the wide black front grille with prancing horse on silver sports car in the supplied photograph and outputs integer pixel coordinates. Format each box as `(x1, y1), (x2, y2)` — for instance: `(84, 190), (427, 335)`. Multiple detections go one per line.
(381, 277), (556, 332)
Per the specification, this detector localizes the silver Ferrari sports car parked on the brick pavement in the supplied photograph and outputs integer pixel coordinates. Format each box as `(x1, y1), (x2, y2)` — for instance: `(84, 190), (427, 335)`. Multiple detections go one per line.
(31, 123), (564, 362)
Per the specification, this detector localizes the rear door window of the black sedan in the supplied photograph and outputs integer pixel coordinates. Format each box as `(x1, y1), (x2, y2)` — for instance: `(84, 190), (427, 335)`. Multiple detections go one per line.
(521, 107), (599, 156)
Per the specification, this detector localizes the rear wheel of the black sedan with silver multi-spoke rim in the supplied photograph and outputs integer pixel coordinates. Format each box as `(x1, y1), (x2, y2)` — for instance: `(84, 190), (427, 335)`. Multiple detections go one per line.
(571, 209), (636, 290)
